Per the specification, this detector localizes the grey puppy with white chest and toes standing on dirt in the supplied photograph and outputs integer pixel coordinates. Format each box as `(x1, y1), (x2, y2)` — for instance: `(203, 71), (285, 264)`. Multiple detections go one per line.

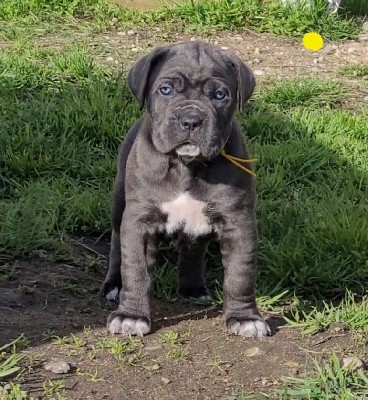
(101, 42), (270, 337)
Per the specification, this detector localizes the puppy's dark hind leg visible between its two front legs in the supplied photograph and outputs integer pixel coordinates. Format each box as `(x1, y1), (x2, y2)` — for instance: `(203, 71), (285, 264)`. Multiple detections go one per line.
(178, 235), (212, 302)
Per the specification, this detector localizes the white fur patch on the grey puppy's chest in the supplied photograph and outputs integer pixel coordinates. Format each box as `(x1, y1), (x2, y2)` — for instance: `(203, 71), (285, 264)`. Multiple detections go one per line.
(160, 193), (212, 236)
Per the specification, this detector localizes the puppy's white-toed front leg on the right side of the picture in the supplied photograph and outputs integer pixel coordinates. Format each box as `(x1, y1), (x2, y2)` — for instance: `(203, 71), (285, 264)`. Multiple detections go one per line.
(220, 213), (271, 337)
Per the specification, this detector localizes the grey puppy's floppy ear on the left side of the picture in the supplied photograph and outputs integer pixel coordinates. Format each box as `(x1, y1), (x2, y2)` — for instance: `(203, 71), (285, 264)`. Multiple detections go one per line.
(127, 47), (168, 109)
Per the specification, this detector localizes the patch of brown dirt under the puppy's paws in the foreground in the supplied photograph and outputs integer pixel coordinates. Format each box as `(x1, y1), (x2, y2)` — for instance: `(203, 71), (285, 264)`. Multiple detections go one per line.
(0, 260), (362, 400)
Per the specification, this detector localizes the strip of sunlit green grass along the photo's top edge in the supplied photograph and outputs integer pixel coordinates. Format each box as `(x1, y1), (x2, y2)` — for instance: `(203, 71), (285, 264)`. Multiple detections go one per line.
(0, 0), (363, 40)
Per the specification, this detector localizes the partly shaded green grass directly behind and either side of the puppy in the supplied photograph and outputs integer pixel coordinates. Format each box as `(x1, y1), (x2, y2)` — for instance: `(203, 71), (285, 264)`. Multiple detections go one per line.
(0, 34), (368, 303)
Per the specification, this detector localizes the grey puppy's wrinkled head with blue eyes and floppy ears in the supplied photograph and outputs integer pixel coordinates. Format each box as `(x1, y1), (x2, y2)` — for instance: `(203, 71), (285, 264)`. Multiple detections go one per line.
(128, 42), (255, 159)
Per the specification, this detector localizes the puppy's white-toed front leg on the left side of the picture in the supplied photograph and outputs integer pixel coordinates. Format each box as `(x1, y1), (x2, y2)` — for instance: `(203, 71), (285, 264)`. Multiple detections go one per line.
(107, 209), (155, 336)
